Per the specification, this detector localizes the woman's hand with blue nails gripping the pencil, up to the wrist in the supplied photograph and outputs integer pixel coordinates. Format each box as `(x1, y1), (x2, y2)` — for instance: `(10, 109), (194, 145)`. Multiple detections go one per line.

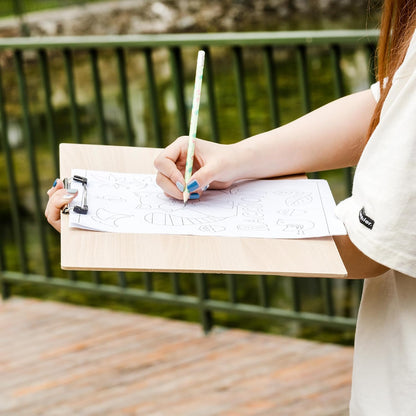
(154, 136), (240, 199)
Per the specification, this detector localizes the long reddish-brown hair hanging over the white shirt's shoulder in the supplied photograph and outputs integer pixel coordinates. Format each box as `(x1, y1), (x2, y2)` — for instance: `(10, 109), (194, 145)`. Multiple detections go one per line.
(368, 0), (416, 137)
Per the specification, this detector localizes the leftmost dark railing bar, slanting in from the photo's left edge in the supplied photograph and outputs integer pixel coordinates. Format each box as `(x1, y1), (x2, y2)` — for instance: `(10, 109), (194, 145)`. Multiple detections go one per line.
(0, 68), (28, 274)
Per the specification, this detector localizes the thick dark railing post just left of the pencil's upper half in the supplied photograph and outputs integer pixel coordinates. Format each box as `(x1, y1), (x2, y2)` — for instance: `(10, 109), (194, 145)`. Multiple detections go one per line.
(169, 47), (189, 135)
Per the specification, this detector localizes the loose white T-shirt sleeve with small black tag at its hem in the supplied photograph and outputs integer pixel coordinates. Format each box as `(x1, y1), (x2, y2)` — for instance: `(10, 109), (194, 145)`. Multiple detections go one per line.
(336, 73), (416, 277)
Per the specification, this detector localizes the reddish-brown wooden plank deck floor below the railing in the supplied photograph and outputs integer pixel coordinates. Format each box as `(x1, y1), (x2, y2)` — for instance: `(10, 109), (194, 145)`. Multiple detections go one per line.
(0, 298), (352, 416)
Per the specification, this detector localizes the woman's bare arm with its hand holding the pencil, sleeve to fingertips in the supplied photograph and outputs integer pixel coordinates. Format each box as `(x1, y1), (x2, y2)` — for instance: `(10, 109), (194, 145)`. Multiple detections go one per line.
(155, 90), (376, 199)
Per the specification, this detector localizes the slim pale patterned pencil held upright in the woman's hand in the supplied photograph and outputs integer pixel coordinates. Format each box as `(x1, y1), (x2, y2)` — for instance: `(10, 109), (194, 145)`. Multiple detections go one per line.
(183, 51), (205, 205)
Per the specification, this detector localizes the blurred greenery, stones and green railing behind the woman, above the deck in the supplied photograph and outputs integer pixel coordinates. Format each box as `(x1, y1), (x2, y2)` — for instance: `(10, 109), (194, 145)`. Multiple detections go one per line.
(0, 0), (380, 345)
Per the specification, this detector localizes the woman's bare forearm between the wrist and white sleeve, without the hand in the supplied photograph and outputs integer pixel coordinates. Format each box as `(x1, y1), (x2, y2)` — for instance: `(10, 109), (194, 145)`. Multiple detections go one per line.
(232, 90), (376, 179)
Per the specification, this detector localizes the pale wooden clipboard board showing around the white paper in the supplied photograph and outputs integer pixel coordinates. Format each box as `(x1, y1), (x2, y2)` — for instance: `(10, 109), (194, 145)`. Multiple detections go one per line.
(60, 144), (347, 278)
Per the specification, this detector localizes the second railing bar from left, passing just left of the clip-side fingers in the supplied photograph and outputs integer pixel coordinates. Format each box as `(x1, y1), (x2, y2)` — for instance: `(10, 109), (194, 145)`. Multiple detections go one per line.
(14, 51), (51, 276)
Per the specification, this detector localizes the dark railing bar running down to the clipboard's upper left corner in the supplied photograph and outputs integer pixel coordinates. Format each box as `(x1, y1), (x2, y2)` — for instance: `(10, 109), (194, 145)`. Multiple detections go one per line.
(38, 49), (59, 177)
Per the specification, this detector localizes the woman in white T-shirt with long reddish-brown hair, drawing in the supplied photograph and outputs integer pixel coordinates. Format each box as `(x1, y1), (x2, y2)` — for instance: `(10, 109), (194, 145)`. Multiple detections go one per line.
(46, 0), (416, 416)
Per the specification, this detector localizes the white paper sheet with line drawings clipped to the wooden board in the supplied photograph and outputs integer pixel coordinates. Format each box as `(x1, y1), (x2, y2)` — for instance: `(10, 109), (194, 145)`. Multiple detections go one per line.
(69, 169), (346, 238)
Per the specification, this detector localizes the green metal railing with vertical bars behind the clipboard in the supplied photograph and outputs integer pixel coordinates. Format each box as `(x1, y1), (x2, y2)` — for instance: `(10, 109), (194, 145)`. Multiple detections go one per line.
(0, 31), (378, 331)
